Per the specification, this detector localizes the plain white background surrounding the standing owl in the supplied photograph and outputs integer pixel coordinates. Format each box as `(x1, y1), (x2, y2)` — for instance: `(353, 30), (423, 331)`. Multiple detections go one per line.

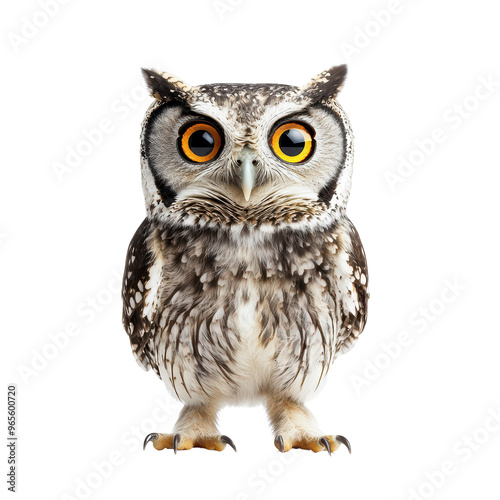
(0, 0), (500, 500)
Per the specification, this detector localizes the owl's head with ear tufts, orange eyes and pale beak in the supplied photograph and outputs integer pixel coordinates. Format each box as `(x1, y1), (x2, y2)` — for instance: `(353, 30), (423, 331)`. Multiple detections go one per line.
(141, 65), (353, 226)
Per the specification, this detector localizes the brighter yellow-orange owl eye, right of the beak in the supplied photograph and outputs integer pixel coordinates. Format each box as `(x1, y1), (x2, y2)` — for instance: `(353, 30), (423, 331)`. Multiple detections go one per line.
(270, 122), (314, 163)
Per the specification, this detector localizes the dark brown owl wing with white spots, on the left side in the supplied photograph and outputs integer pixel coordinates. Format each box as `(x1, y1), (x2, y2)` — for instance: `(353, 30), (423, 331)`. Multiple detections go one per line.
(122, 218), (162, 375)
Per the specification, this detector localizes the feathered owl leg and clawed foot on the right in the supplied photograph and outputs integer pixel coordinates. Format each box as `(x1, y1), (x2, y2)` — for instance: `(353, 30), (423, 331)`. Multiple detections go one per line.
(267, 399), (351, 454)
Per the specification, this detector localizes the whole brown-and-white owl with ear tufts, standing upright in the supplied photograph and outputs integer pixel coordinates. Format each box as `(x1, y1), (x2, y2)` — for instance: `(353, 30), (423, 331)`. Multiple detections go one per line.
(122, 66), (368, 454)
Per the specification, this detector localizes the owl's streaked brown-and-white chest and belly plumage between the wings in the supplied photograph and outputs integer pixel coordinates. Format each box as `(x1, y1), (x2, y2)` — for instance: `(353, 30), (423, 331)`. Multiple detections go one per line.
(141, 217), (364, 401)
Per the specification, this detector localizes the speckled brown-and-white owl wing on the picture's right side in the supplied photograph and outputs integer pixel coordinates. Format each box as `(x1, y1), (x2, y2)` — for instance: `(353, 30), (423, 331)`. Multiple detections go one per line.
(335, 217), (370, 357)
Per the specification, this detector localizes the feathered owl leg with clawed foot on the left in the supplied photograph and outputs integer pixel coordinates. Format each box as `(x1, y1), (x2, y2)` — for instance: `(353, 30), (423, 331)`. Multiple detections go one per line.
(144, 405), (236, 453)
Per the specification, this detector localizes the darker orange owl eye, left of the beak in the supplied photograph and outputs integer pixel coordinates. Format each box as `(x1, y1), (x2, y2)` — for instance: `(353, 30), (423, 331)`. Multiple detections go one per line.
(178, 122), (222, 163)
